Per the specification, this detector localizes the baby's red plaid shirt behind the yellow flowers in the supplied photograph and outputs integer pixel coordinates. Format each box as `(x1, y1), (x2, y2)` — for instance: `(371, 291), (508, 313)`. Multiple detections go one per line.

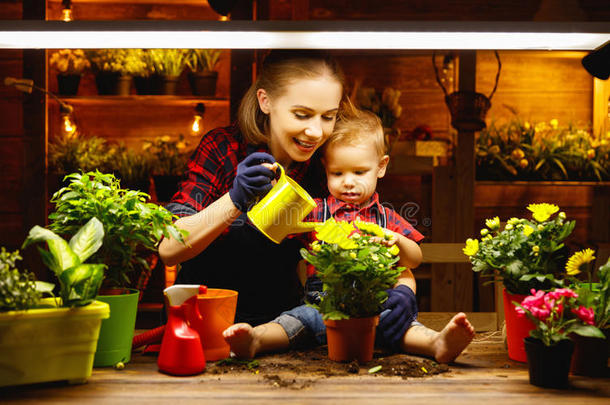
(304, 193), (424, 278)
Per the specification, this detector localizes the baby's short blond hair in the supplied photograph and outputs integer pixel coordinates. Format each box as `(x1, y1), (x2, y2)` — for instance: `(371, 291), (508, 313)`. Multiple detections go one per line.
(322, 105), (387, 157)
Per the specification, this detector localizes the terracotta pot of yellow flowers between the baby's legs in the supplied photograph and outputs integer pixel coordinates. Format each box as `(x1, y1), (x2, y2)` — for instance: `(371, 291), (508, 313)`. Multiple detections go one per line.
(324, 316), (379, 363)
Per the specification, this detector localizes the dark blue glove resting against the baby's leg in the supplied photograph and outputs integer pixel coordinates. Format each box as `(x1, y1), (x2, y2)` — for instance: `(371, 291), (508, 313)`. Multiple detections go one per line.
(379, 284), (417, 348)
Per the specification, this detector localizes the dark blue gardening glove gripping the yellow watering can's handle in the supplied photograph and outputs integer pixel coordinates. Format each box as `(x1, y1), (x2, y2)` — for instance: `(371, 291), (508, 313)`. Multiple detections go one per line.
(229, 152), (275, 212)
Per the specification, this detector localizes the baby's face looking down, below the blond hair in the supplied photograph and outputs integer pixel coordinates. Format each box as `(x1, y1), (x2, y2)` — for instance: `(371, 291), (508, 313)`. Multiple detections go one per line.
(324, 141), (389, 205)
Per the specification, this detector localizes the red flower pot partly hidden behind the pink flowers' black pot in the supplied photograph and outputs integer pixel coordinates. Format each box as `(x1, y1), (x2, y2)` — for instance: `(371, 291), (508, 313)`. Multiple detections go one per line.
(502, 289), (535, 363)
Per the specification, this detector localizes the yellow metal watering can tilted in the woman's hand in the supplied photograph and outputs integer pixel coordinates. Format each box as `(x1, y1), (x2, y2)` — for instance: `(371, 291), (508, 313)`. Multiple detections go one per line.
(248, 163), (320, 243)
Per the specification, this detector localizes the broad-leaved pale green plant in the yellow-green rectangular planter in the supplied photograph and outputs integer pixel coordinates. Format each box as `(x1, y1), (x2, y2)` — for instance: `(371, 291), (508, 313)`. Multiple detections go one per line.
(22, 217), (106, 307)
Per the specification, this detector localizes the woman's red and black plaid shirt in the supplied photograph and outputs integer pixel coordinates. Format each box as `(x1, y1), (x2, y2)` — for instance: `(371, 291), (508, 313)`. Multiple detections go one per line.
(166, 124), (325, 217)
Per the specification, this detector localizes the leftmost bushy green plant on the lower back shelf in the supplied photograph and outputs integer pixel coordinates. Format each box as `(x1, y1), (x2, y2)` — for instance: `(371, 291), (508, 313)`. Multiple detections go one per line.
(49, 135), (113, 175)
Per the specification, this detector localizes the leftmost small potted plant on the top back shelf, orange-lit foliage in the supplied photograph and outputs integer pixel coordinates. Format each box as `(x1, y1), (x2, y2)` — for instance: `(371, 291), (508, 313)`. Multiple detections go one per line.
(49, 49), (91, 96)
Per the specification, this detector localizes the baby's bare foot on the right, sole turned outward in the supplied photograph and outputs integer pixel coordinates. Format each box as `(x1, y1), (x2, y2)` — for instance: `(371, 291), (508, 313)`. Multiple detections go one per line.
(434, 312), (474, 363)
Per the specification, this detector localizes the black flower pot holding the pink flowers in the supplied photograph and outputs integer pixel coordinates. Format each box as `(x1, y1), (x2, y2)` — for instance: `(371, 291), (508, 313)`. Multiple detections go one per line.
(524, 337), (574, 388)
